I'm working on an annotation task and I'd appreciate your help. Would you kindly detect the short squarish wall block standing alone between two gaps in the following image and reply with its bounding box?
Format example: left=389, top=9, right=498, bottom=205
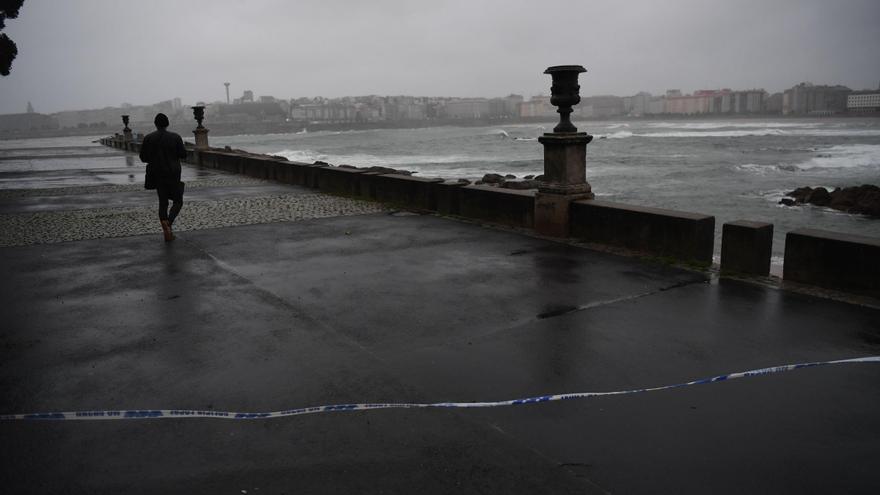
left=721, top=220, right=773, bottom=277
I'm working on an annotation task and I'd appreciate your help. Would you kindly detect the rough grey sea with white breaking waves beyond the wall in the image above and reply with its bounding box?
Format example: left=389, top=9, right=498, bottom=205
left=0, top=118, right=880, bottom=263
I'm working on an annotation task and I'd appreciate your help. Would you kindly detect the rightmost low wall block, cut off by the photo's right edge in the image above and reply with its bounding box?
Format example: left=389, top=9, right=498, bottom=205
left=782, top=229, right=880, bottom=297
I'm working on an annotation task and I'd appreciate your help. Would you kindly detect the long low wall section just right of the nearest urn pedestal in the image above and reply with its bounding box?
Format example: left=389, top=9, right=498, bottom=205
left=570, top=199, right=715, bottom=265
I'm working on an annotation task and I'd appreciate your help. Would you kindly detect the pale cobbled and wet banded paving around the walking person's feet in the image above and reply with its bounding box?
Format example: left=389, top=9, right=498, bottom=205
left=0, top=145, right=384, bottom=247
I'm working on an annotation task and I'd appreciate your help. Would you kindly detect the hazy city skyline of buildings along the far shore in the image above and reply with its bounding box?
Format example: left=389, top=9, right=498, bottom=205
left=0, top=83, right=880, bottom=137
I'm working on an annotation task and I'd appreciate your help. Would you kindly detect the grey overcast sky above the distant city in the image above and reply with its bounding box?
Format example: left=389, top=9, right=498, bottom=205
left=0, top=0, right=880, bottom=113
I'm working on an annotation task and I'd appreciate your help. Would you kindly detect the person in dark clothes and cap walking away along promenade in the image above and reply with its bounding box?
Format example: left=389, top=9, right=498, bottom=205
left=140, top=113, right=186, bottom=242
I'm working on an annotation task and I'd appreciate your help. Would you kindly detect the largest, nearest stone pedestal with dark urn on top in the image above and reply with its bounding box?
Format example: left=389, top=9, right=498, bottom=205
left=535, top=65, right=593, bottom=237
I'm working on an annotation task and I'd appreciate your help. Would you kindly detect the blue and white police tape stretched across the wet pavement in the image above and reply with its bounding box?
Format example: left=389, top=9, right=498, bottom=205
left=0, top=356, right=880, bottom=421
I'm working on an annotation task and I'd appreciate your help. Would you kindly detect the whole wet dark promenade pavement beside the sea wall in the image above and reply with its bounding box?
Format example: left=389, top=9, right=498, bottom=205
left=0, top=141, right=880, bottom=494
